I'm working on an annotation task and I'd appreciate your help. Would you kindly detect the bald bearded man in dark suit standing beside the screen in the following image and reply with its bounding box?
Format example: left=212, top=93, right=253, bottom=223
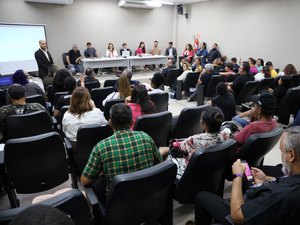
left=34, top=40, right=53, bottom=79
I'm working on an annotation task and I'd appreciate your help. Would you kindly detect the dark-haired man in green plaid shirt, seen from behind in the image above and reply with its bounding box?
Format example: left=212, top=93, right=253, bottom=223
left=81, top=103, right=162, bottom=192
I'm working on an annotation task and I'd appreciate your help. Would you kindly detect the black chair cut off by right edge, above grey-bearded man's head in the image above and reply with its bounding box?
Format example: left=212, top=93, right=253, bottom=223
left=275, top=86, right=300, bottom=125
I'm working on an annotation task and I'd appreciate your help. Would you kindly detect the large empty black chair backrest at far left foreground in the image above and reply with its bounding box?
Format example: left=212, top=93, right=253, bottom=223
left=4, top=132, right=69, bottom=193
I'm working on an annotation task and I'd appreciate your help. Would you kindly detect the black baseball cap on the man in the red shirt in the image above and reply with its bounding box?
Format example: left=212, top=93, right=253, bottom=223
left=251, top=92, right=277, bottom=114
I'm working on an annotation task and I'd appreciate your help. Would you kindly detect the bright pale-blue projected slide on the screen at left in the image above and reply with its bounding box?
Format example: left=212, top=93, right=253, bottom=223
left=0, top=23, right=46, bottom=75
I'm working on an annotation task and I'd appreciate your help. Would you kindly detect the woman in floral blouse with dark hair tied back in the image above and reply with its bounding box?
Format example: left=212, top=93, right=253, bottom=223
left=168, top=106, right=230, bottom=179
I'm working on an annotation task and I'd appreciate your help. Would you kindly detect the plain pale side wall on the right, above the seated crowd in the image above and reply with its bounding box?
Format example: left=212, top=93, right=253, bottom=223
left=178, top=0, right=300, bottom=70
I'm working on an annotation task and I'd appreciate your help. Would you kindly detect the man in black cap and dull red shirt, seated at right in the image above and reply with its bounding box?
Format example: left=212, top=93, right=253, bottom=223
left=234, top=92, right=277, bottom=145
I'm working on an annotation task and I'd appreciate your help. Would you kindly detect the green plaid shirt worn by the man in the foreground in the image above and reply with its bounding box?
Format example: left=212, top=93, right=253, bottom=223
left=82, top=129, right=162, bottom=183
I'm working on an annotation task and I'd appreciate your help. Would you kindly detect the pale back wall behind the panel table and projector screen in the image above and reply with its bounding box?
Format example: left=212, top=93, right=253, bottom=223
left=0, top=0, right=177, bottom=66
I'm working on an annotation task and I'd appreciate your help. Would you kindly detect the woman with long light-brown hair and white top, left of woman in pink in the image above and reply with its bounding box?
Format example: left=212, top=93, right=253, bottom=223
left=102, top=74, right=131, bottom=106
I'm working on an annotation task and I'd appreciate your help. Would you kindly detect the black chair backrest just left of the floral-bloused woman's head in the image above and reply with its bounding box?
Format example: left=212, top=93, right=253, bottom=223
left=171, top=105, right=208, bottom=138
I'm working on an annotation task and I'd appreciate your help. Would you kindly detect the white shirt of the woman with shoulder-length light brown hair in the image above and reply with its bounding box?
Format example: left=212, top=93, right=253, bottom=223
left=62, top=108, right=107, bottom=141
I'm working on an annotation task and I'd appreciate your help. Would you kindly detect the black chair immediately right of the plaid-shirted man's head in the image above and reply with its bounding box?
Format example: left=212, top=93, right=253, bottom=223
left=133, top=112, right=172, bottom=147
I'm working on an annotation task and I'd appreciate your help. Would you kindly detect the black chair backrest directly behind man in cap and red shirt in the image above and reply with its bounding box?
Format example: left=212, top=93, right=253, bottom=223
left=237, top=127, right=283, bottom=167
